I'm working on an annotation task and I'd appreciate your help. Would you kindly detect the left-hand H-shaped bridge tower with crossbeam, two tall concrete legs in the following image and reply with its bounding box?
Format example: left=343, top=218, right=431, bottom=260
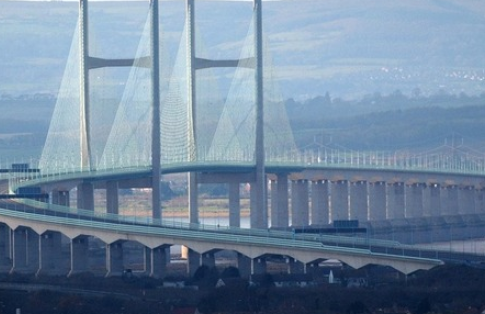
left=79, top=0, right=161, bottom=218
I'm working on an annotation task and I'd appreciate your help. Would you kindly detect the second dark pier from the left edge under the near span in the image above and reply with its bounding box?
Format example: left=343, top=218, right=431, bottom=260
left=11, top=227, right=39, bottom=273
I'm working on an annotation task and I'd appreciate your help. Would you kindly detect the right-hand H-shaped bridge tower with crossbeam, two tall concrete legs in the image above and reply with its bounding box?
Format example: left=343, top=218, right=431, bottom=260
left=186, top=0, right=268, bottom=228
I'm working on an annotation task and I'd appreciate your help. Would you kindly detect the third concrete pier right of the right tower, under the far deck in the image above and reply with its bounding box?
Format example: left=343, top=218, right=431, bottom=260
left=311, top=180, right=330, bottom=226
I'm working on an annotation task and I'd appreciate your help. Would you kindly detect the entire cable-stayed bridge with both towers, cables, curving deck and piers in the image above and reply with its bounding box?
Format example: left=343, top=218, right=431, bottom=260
left=0, top=0, right=485, bottom=276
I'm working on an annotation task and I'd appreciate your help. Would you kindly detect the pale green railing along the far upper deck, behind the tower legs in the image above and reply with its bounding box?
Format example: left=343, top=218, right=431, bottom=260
left=3, top=146, right=485, bottom=190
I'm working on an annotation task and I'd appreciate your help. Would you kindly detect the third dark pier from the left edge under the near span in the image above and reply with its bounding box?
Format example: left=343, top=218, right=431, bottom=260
left=37, top=231, right=64, bottom=275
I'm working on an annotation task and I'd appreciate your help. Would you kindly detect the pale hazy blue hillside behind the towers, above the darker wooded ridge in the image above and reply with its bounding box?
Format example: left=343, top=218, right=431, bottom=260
left=0, top=0, right=485, bottom=99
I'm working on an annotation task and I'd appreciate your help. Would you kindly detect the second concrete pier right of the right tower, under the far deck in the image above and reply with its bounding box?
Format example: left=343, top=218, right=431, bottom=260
left=291, top=180, right=309, bottom=227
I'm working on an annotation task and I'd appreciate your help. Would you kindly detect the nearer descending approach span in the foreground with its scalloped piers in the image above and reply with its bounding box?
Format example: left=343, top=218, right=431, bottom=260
left=0, top=201, right=442, bottom=277
